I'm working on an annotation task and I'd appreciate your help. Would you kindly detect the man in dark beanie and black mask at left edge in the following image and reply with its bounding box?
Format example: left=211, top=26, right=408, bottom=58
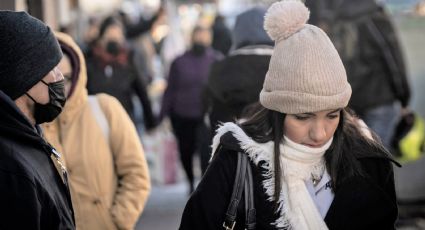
left=0, top=11, right=75, bottom=229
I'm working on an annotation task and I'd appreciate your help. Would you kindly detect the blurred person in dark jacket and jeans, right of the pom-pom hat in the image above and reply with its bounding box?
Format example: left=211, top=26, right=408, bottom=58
left=306, top=0, right=410, bottom=147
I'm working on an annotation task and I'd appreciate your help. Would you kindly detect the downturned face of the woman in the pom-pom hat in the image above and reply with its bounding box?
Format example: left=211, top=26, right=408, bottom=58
left=283, top=109, right=341, bottom=148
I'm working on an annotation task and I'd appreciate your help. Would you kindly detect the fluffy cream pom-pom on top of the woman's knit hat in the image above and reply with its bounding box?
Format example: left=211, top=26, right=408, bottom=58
left=264, top=0, right=310, bottom=41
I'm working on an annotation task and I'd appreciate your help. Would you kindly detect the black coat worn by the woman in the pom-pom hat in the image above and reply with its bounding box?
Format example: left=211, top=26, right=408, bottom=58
left=180, top=125, right=398, bottom=230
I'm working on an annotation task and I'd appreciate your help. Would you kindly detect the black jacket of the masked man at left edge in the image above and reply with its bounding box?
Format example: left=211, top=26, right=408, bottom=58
left=0, top=91, right=75, bottom=230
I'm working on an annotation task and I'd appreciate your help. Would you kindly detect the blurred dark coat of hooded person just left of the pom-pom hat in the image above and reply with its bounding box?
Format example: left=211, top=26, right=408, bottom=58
left=206, top=45, right=273, bottom=129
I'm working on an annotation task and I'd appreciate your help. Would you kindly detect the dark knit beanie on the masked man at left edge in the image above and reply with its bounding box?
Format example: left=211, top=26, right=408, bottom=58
left=0, top=11, right=62, bottom=100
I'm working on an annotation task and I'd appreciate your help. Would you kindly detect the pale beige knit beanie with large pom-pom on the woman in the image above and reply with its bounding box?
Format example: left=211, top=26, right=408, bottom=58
left=260, top=0, right=351, bottom=114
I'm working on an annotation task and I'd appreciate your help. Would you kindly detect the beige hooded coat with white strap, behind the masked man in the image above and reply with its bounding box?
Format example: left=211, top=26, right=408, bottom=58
left=43, top=34, right=150, bottom=230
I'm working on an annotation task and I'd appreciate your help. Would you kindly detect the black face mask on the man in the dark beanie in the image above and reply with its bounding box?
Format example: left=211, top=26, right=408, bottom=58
left=26, top=80, right=66, bottom=124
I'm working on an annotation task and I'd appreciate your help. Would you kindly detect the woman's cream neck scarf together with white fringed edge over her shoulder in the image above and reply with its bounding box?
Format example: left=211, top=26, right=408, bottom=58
left=212, top=122, right=333, bottom=230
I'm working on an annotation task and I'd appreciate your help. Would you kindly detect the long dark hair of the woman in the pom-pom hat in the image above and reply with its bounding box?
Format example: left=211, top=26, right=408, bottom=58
left=240, top=103, right=392, bottom=207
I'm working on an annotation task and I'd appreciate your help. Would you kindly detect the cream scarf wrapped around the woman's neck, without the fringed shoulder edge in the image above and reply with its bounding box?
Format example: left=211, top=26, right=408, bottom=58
left=280, top=136, right=333, bottom=230
